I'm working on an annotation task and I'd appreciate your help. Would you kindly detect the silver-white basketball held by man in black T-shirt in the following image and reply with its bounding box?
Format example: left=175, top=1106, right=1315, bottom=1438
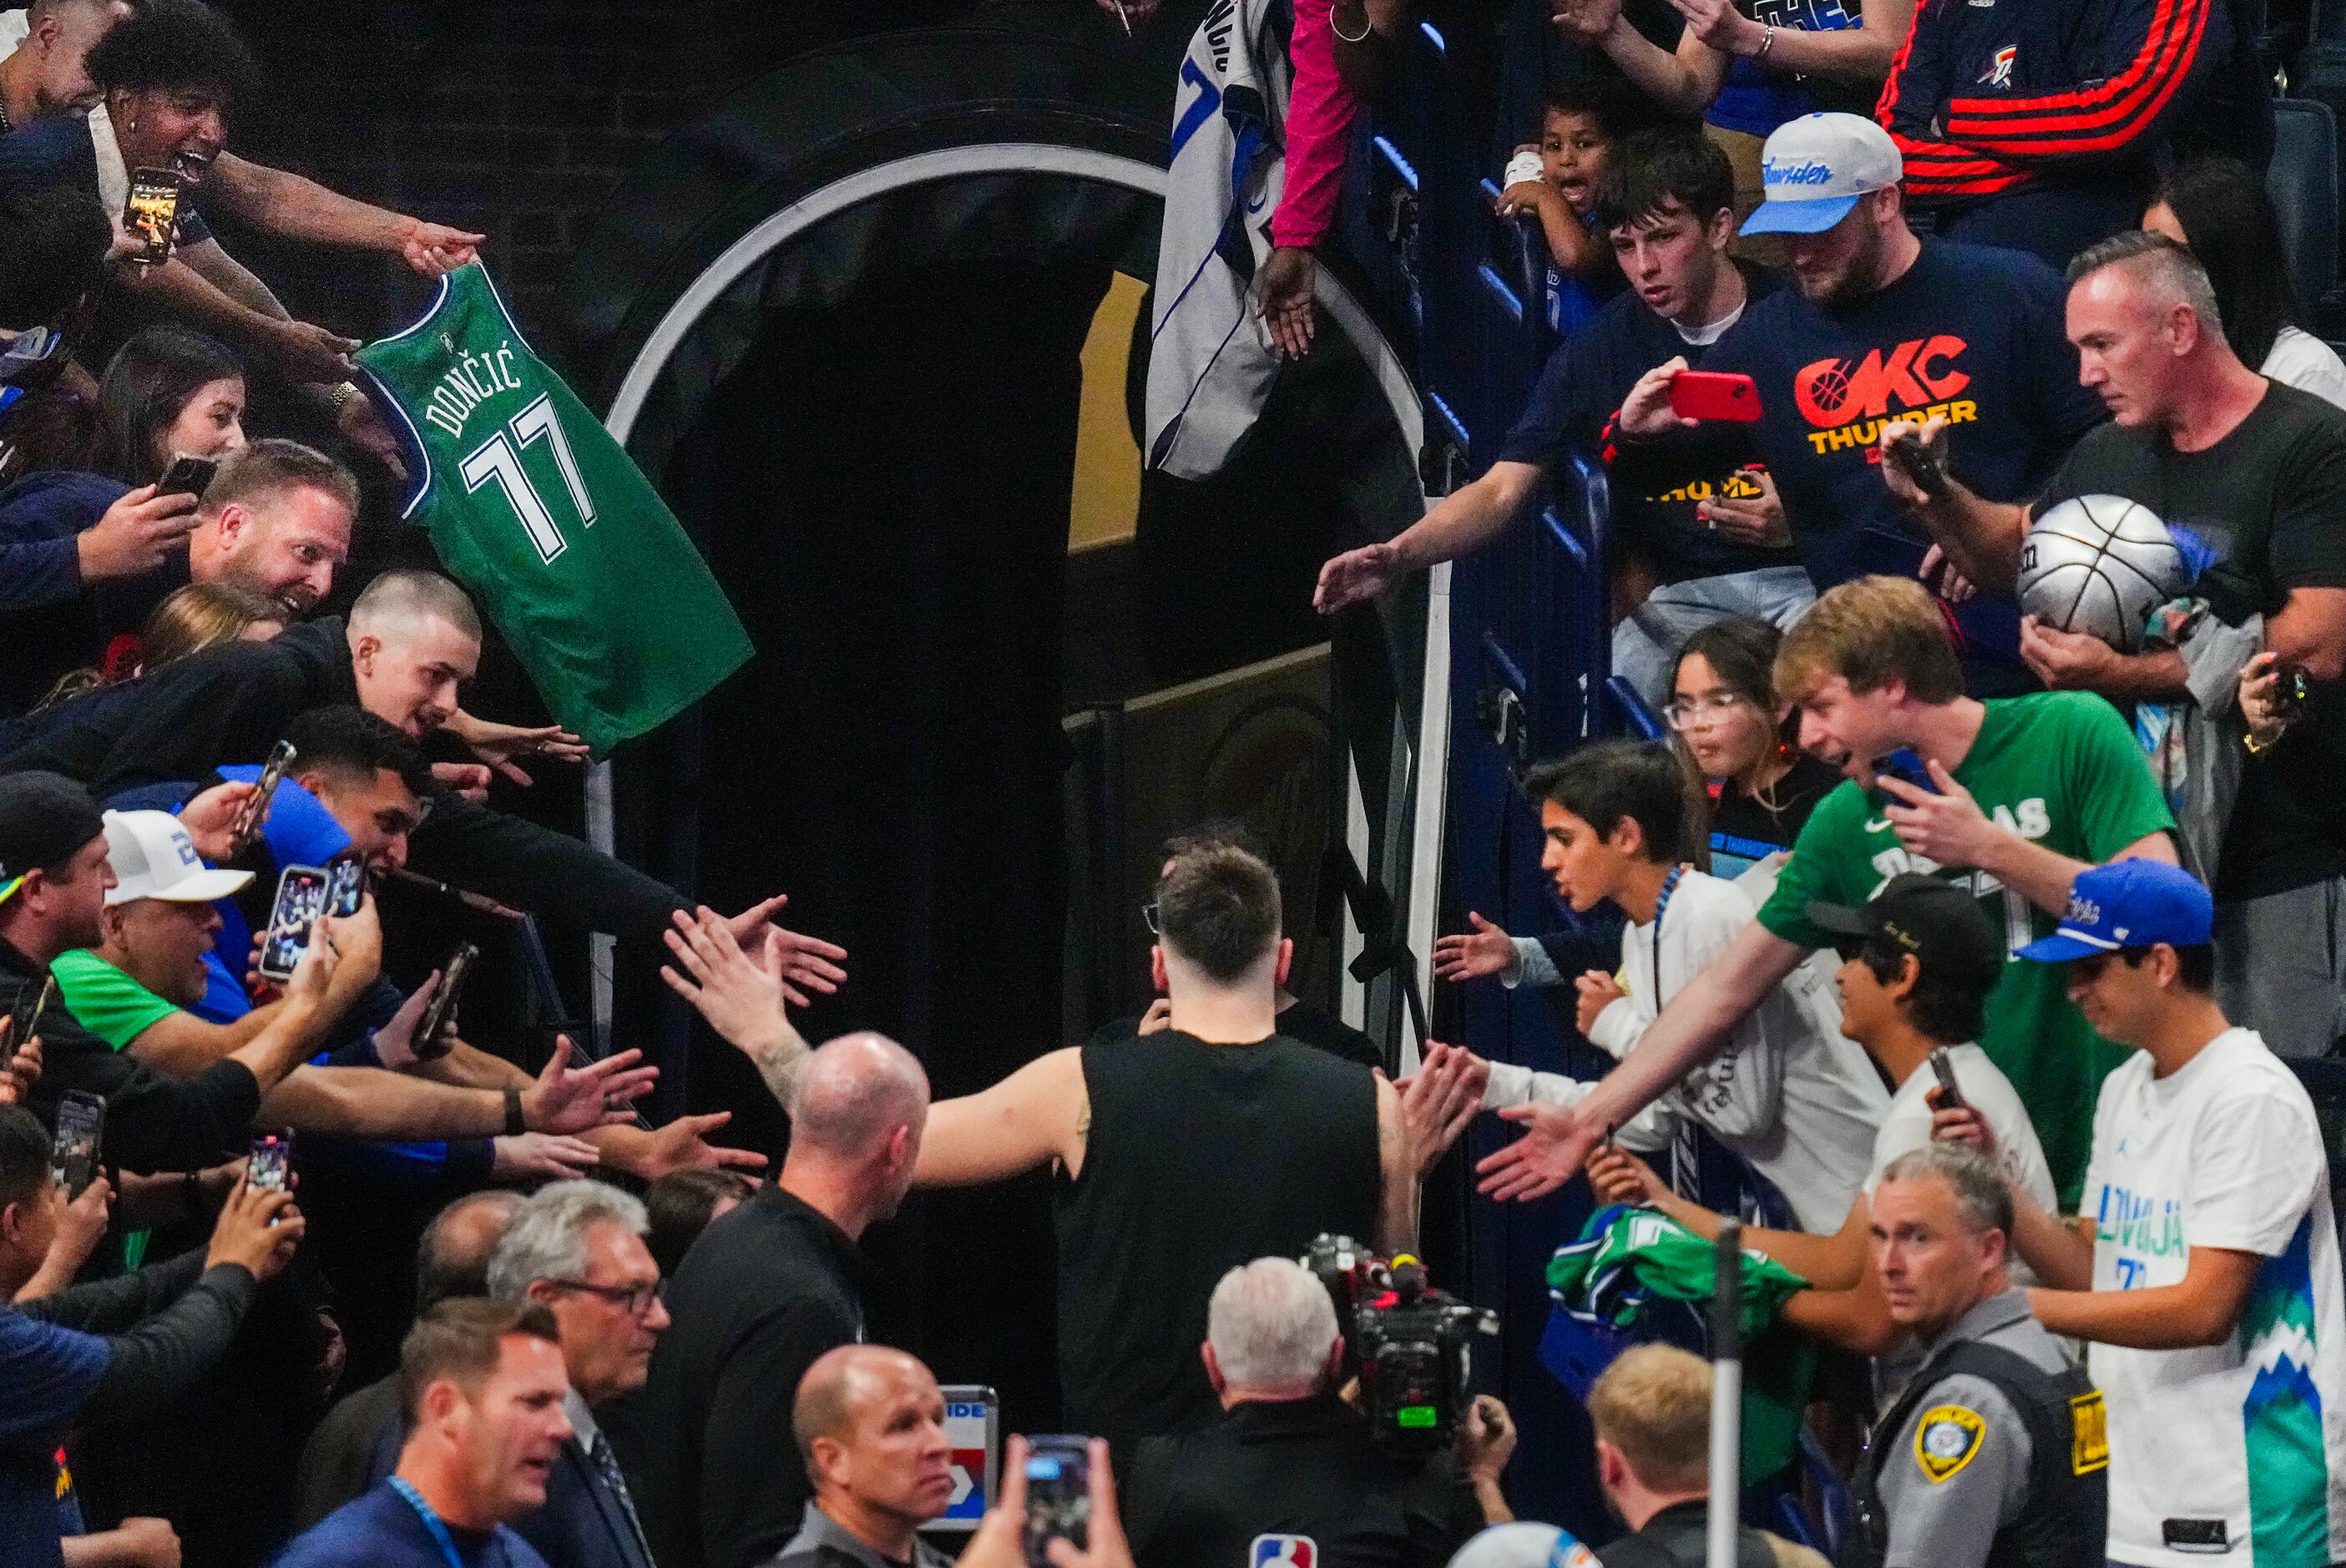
left=2020, top=495, right=2192, bottom=653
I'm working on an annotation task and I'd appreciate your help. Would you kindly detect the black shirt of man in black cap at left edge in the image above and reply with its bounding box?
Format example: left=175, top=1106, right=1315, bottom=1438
left=0, top=941, right=260, bottom=1171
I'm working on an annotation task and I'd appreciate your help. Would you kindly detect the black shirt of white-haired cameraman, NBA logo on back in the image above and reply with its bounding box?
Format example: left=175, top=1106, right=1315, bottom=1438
left=1124, top=1394, right=1483, bottom=1568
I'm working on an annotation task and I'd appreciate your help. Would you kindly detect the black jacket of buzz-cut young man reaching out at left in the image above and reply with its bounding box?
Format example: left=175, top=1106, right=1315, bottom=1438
left=0, top=615, right=685, bottom=943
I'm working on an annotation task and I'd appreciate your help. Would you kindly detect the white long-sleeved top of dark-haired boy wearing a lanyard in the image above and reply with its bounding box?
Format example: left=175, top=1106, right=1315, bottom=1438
left=1483, top=871, right=1888, bottom=1235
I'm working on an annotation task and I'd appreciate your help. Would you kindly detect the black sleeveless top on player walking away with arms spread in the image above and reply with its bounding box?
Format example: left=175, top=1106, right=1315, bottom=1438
left=1054, top=1028, right=1382, bottom=1446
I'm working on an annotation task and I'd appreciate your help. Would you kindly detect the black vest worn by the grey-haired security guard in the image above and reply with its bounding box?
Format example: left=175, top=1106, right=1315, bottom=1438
left=1853, top=1340, right=2109, bottom=1568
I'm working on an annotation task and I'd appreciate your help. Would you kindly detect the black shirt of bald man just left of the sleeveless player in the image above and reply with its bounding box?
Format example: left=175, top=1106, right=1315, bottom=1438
left=636, top=1186, right=871, bottom=1568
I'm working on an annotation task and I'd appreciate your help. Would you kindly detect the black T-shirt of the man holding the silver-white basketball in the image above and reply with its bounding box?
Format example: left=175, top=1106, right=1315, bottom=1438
left=2036, top=380, right=2346, bottom=903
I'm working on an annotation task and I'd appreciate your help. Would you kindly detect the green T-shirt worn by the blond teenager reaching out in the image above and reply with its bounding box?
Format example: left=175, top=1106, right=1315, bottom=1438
left=1760, top=692, right=2175, bottom=1204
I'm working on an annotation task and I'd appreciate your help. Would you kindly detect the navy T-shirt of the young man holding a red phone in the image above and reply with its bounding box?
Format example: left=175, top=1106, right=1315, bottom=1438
left=1499, top=267, right=1799, bottom=582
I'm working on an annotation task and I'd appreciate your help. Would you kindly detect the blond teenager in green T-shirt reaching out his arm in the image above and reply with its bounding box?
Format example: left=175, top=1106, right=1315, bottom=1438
left=1480, top=578, right=2175, bottom=1201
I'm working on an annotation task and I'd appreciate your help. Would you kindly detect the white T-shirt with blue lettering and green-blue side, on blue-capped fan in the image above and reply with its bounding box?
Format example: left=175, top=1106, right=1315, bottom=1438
left=2083, top=1028, right=2346, bottom=1568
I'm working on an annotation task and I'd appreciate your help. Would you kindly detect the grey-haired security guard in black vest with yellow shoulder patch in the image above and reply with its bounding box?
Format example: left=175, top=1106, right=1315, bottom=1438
left=1856, top=1143, right=2109, bottom=1568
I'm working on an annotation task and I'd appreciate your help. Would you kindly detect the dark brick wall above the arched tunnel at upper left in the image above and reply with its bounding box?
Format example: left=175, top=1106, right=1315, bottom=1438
left=218, top=0, right=1125, bottom=363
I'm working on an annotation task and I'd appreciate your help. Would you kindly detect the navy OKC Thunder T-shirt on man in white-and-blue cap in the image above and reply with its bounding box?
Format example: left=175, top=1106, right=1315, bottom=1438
left=1703, top=240, right=2102, bottom=591
